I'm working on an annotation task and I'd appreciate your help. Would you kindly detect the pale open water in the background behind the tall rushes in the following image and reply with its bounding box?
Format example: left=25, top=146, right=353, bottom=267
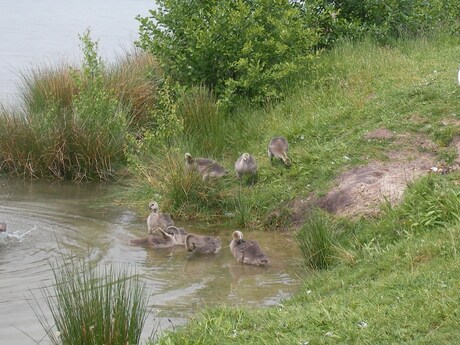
left=0, top=0, right=155, bottom=104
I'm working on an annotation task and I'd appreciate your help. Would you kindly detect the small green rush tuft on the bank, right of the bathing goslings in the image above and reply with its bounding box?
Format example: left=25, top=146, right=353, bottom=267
left=295, top=210, right=336, bottom=270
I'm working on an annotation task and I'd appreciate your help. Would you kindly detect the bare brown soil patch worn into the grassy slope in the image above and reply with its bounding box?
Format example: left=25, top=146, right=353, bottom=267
left=272, top=129, right=460, bottom=227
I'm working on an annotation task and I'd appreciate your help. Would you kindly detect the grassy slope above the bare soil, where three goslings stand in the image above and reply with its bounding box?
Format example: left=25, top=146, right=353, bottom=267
left=128, top=32, right=459, bottom=223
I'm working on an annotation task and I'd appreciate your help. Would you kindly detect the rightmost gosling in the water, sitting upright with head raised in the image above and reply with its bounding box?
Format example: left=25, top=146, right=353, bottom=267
left=230, top=231, right=269, bottom=266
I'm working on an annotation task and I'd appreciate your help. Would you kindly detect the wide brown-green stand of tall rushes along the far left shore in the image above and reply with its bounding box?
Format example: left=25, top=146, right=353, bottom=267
left=0, top=32, right=159, bottom=180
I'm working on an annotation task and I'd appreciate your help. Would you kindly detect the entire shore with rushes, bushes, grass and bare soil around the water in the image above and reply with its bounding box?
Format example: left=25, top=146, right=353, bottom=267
left=0, top=0, right=460, bottom=344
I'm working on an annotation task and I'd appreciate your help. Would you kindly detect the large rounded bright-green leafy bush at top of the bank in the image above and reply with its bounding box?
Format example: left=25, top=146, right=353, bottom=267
left=137, top=0, right=319, bottom=101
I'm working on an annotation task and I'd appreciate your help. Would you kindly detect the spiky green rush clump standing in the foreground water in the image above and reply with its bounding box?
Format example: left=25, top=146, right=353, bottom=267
left=33, top=259, right=148, bottom=345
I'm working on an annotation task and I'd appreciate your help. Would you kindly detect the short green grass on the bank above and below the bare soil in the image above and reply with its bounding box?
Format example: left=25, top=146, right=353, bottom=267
left=146, top=36, right=460, bottom=344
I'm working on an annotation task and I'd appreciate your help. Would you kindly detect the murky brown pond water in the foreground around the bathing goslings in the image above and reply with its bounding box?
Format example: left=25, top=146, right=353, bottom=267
left=0, top=178, right=299, bottom=345
